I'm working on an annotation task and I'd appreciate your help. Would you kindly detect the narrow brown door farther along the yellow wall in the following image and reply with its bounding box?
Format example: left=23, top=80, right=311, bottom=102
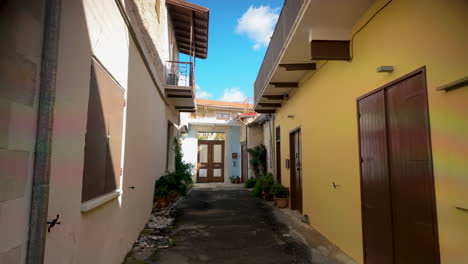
left=289, top=130, right=302, bottom=213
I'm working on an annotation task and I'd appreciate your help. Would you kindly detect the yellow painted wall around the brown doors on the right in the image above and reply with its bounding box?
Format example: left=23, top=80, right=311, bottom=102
left=275, top=0, right=468, bottom=264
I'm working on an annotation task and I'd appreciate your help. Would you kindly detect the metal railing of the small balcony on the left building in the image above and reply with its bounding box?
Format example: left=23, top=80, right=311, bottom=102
left=164, top=61, right=195, bottom=87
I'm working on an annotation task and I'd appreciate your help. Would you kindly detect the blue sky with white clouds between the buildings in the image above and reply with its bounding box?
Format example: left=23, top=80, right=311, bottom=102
left=183, top=0, right=284, bottom=101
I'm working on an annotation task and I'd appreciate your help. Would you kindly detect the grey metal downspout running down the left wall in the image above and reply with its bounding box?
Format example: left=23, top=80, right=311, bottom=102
left=26, top=0, right=62, bottom=264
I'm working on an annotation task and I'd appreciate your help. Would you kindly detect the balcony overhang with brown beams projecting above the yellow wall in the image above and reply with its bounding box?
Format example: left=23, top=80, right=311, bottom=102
left=255, top=0, right=375, bottom=113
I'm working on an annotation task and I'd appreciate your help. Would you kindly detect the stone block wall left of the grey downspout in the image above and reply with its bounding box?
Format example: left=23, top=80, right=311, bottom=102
left=0, top=0, right=44, bottom=263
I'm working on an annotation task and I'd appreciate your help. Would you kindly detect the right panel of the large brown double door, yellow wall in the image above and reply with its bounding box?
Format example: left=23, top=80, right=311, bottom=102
left=386, top=74, right=438, bottom=264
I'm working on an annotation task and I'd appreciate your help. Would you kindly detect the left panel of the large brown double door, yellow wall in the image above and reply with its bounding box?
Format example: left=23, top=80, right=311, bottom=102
left=359, top=91, right=393, bottom=264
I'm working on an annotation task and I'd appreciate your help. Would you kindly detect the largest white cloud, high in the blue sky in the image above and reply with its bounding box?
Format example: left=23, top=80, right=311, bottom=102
left=236, top=5, right=279, bottom=49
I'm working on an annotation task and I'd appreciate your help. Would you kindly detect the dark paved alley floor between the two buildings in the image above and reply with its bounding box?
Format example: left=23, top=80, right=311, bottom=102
left=155, top=185, right=312, bottom=264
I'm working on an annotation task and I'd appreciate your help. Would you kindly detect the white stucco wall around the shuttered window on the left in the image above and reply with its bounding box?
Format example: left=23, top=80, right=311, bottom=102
left=45, top=0, right=178, bottom=264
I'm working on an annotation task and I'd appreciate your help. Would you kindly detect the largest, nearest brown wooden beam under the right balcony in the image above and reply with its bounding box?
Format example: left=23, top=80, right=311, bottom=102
left=310, top=40, right=351, bottom=60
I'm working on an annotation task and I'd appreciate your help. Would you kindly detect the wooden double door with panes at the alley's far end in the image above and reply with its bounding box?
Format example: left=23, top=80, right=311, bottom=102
left=197, top=140, right=224, bottom=183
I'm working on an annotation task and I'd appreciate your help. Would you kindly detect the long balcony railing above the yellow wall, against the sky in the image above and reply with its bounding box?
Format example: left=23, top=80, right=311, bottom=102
left=254, top=0, right=305, bottom=102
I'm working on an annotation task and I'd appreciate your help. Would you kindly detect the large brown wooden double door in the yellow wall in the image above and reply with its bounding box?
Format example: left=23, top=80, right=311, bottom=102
left=358, top=68, right=440, bottom=264
